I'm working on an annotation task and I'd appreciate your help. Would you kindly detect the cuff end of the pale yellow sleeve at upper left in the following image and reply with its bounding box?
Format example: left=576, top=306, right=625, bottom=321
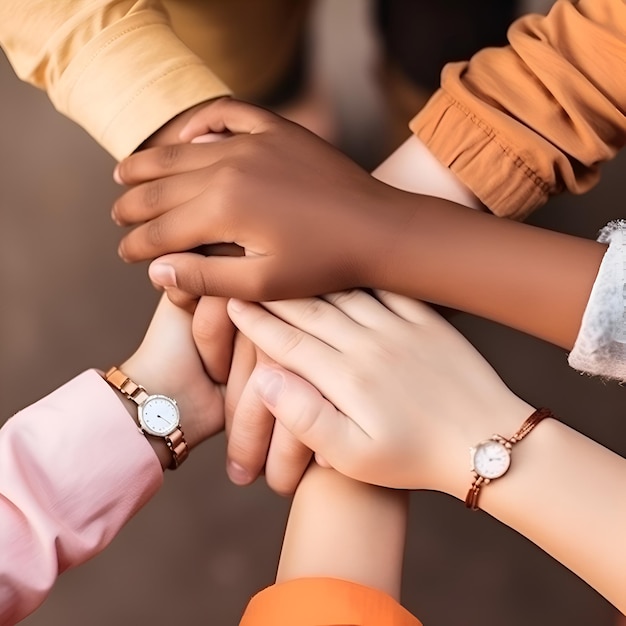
left=49, top=12, right=231, bottom=160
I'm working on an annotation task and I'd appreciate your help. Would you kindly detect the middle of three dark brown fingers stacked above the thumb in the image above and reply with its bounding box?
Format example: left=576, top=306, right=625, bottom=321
left=111, top=169, right=214, bottom=226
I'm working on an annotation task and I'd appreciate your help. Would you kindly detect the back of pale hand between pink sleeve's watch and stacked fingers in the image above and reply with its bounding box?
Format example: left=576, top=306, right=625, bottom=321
left=120, top=295, right=224, bottom=448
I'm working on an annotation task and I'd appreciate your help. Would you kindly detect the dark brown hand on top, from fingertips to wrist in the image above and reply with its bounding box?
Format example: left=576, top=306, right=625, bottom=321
left=113, top=99, right=411, bottom=300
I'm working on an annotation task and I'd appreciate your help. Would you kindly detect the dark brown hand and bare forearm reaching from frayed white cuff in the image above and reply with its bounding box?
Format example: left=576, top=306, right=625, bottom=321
left=113, top=99, right=606, bottom=348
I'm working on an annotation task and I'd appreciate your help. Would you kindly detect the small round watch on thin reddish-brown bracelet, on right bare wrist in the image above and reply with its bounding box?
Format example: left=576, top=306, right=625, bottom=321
left=465, top=408, right=554, bottom=511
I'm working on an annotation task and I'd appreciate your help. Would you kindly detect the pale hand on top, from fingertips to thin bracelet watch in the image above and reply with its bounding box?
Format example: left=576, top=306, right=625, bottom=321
left=228, top=291, right=533, bottom=498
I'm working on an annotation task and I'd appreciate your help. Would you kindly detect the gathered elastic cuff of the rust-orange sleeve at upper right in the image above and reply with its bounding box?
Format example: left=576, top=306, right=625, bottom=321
left=410, top=89, right=551, bottom=220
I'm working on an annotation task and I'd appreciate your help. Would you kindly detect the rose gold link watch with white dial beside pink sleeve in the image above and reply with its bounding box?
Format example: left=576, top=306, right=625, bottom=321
left=104, top=367, right=189, bottom=469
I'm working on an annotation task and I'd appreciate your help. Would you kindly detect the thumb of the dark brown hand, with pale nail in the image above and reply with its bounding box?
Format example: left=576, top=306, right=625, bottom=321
left=147, top=252, right=271, bottom=300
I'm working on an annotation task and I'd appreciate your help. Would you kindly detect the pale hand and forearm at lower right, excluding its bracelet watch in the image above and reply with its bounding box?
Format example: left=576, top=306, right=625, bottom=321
left=229, top=291, right=626, bottom=611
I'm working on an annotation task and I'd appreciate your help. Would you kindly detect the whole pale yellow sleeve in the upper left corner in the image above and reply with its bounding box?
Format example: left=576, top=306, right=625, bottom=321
left=0, top=0, right=230, bottom=160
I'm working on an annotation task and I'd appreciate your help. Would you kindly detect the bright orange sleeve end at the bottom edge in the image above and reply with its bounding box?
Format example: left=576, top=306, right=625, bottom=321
left=239, top=578, right=421, bottom=626
